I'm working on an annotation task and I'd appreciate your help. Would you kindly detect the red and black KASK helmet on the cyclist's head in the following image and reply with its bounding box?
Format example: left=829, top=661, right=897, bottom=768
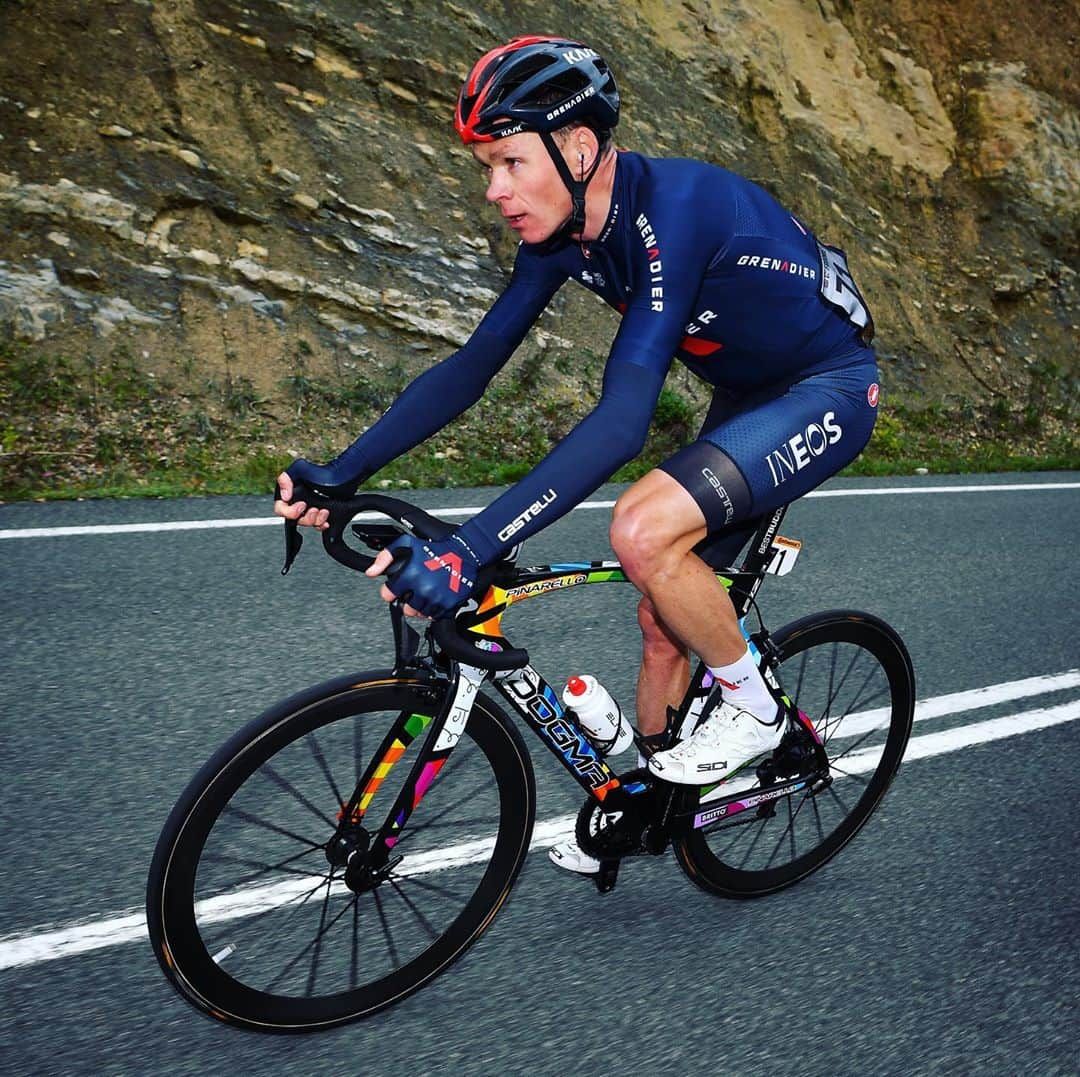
left=454, top=37, right=619, bottom=145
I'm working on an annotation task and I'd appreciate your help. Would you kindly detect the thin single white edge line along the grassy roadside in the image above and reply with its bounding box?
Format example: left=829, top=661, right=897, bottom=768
left=0, top=483, right=1080, bottom=539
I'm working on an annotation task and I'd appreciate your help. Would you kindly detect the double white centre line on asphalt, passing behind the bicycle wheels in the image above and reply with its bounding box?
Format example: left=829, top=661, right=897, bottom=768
left=0, top=670, right=1080, bottom=969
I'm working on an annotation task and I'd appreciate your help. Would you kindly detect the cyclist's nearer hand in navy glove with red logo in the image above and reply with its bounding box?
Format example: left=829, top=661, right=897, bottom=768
left=367, top=535, right=480, bottom=617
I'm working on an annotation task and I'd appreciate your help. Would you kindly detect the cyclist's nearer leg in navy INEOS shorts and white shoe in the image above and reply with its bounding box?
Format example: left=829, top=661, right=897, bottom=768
left=611, top=362, right=877, bottom=782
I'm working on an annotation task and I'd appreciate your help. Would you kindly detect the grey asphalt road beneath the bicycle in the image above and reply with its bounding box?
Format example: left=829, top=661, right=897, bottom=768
left=0, top=473, right=1080, bottom=1075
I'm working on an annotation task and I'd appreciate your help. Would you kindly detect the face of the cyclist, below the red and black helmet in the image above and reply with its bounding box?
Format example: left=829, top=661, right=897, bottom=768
left=472, top=132, right=570, bottom=243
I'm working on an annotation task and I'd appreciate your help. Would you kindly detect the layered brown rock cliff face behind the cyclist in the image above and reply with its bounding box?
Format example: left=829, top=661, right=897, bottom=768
left=0, top=0, right=1080, bottom=479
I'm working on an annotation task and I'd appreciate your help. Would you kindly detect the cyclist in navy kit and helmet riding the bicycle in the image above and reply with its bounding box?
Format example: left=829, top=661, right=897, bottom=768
left=275, top=37, right=878, bottom=873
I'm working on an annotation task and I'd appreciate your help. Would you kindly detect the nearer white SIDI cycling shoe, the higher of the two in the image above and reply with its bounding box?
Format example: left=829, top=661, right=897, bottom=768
left=649, top=702, right=786, bottom=785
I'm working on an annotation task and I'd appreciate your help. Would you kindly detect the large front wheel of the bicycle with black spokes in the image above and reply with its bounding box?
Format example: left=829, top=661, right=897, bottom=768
left=147, top=672, right=536, bottom=1033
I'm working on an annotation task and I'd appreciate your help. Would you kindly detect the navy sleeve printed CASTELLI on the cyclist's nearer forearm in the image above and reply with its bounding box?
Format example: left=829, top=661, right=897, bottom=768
left=458, top=363, right=663, bottom=564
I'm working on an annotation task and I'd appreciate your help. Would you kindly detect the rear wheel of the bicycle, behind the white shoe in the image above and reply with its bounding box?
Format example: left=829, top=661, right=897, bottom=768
left=675, top=610, right=915, bottom=898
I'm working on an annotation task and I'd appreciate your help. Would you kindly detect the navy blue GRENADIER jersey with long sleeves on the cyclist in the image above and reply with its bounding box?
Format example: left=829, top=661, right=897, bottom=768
left=356, top=152, right=873, bottom=563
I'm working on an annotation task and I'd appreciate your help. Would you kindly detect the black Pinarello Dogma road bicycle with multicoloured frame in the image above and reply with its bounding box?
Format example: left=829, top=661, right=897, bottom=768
left=147, top=489, right=915, bottom=1032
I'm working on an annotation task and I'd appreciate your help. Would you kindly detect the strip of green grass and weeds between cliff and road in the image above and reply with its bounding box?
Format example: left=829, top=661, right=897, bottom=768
left=0, top=345, right=1080, bottom=500
